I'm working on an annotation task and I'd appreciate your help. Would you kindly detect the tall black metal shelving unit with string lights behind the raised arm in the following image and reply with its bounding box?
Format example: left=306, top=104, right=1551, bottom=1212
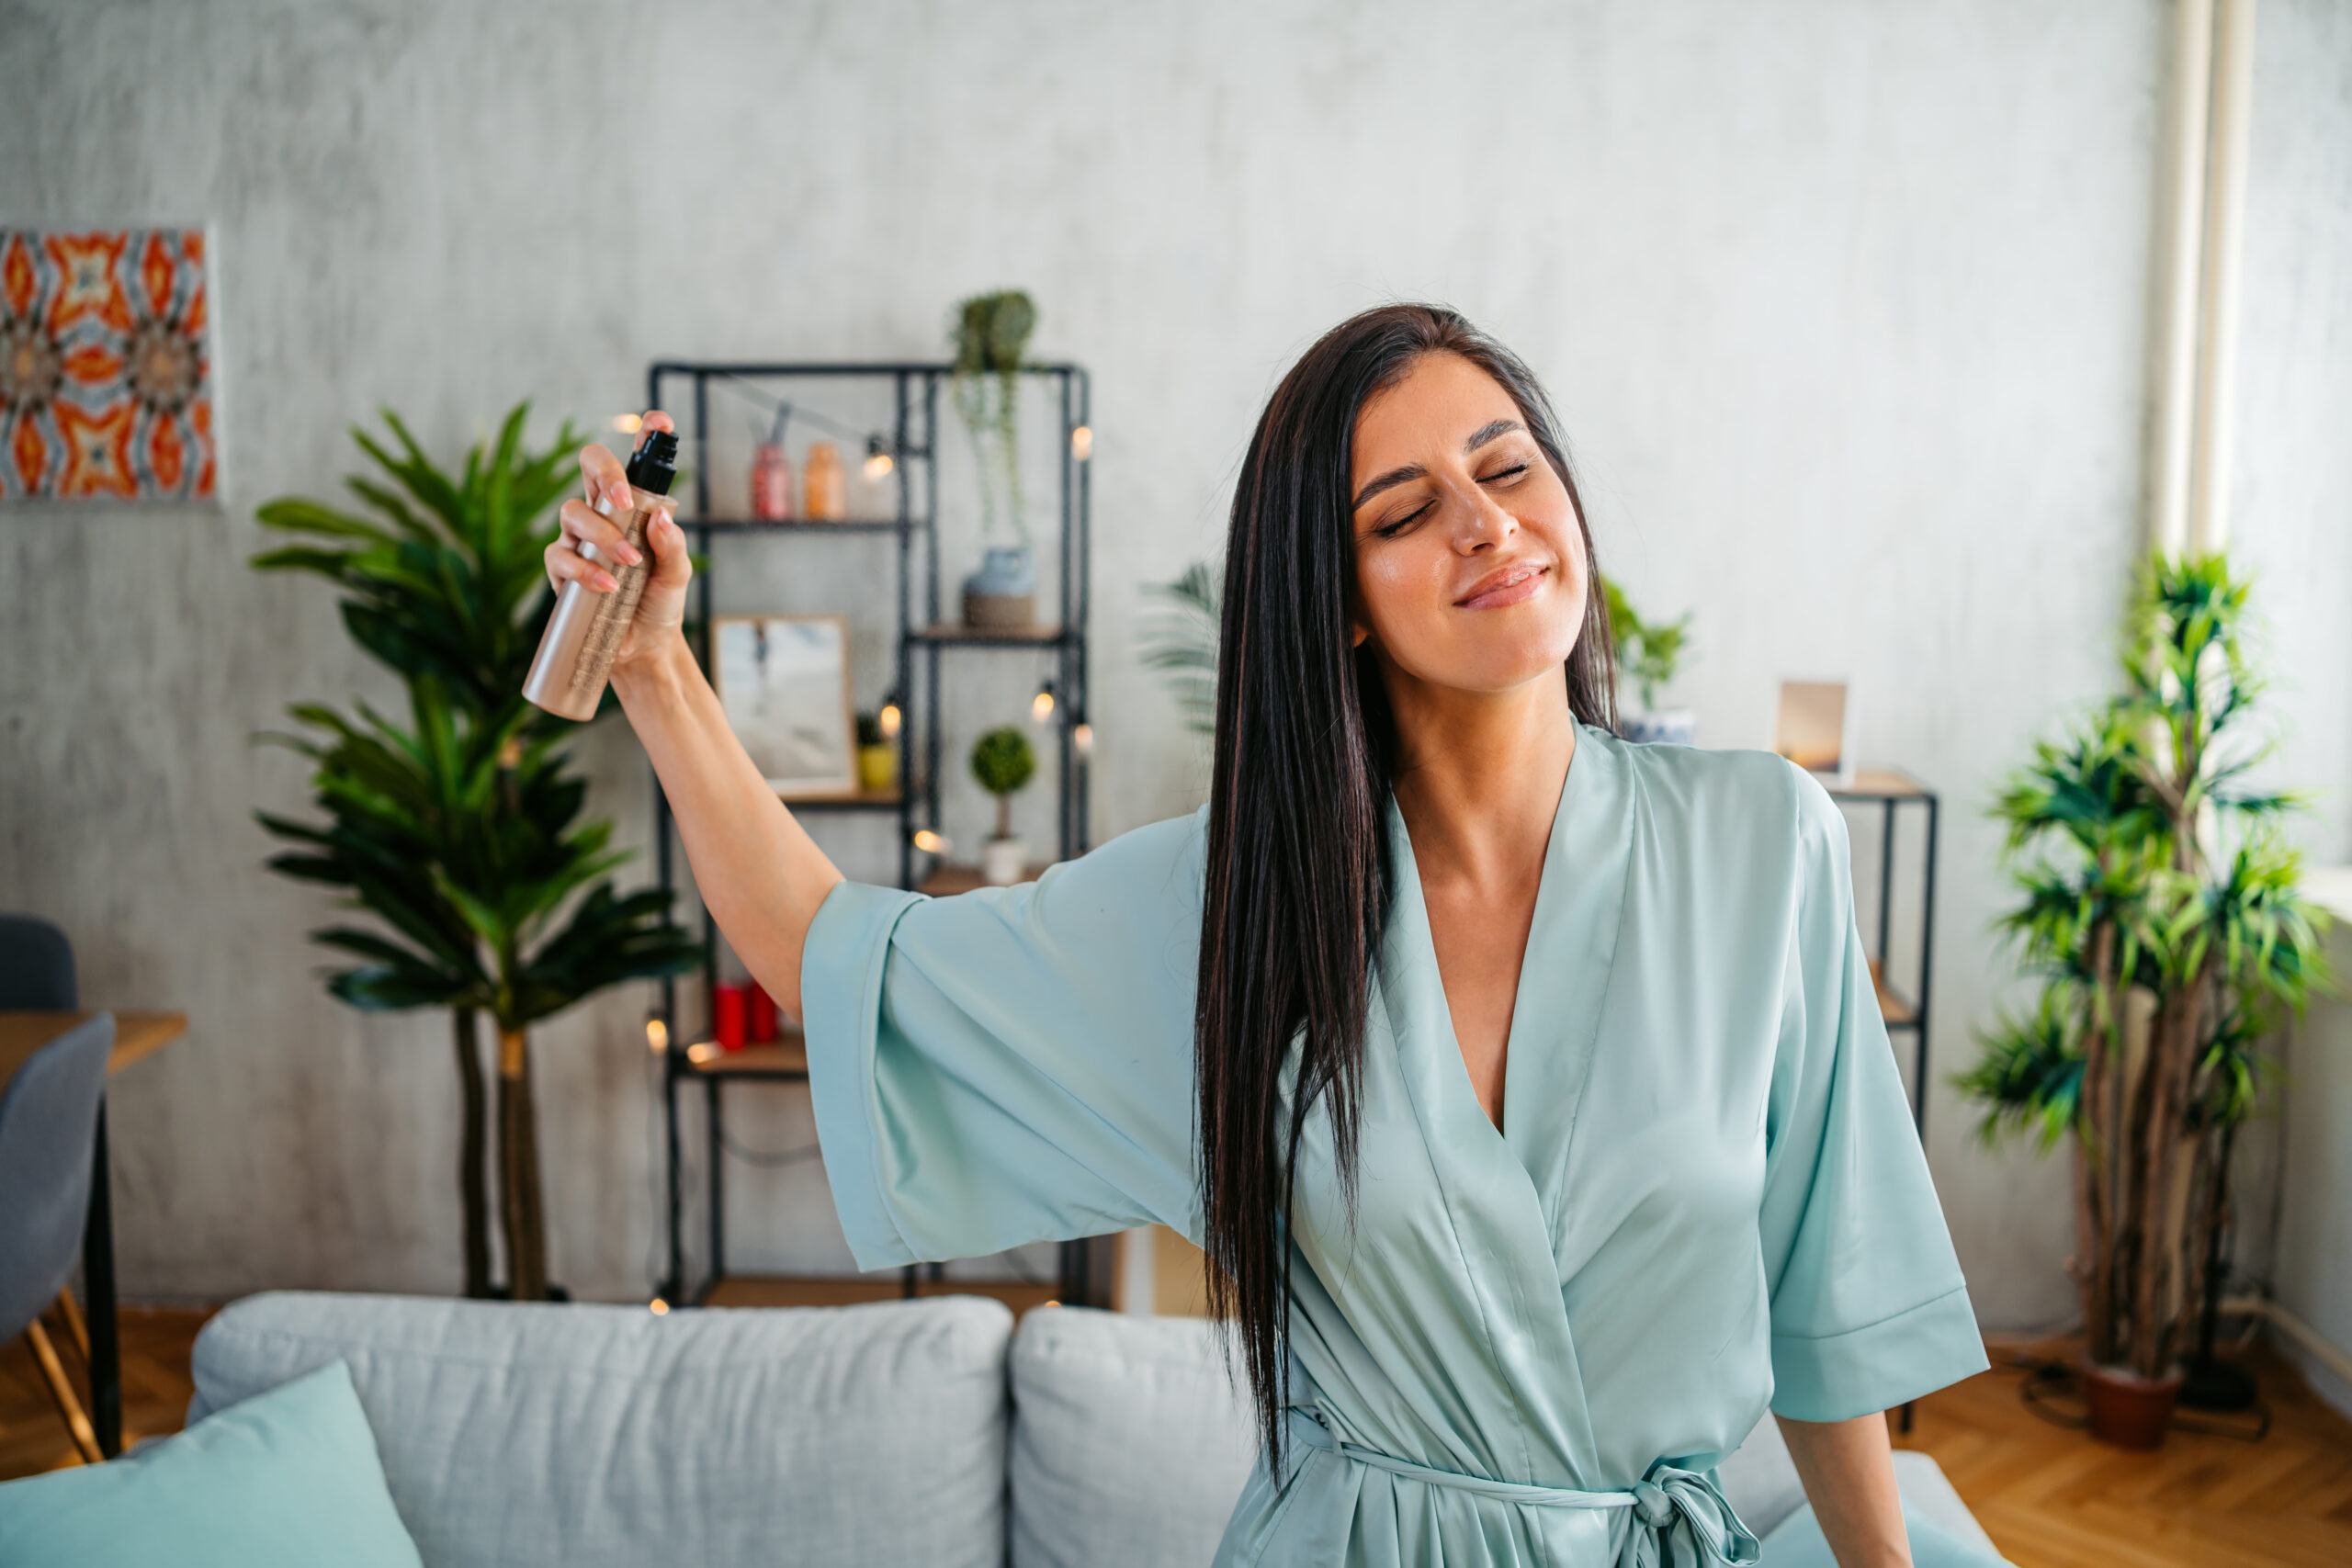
left=647, top=360, right=1110, bottom=1304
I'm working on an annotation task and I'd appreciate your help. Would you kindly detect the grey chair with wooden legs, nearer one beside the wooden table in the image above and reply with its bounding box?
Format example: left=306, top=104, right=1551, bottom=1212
left=0, top=1013, right=115, bottom=1464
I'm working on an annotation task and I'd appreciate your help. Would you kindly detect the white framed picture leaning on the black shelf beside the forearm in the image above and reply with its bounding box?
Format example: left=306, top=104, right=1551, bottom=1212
left=710, top=616, right=858, bottom=799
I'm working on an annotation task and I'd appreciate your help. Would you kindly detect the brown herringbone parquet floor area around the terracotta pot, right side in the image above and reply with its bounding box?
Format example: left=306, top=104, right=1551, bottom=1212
left=1895, top=1342, right=2352, bottom=1568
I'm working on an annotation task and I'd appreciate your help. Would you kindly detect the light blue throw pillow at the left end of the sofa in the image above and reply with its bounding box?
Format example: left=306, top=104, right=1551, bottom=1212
left=0, top=1361, right=424, bottom=1568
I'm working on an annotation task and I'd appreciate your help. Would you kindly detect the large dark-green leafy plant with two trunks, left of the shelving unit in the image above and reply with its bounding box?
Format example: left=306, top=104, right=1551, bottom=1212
left=254, top=404, right=701, bottom=1300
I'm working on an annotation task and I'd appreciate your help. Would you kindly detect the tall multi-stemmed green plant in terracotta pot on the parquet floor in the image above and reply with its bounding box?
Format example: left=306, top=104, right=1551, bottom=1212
left=1952, top=555, right=2326, bottom=1448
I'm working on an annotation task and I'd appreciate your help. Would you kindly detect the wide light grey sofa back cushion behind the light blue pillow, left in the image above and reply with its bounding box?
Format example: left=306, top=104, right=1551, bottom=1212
left=188, top=1293, right=1012, bottom=1568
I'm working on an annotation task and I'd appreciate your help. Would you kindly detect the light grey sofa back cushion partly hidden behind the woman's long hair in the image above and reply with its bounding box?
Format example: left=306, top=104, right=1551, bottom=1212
left=1012, top=1307, right=1259, bottom=1568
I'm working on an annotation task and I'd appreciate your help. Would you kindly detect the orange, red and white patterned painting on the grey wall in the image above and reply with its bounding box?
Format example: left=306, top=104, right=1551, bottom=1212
left=0, top=228, right=214, bottom=501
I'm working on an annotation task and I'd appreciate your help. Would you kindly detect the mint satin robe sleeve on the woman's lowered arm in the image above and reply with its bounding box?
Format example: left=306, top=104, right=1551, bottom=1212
left=1759, top=764, right=1990, bottom=1422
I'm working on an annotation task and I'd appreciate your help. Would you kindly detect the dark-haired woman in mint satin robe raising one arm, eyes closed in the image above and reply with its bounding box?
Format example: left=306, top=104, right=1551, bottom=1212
left=548, top=306, right=1985, bottom=1568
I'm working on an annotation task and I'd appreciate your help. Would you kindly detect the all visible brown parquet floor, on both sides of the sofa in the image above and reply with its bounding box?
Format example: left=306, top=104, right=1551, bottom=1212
left=14, top=1309, right=2352, bottom=1568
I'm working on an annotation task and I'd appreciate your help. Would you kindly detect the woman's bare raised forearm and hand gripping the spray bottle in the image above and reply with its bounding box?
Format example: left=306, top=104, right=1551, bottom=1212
left=546, top=409, right=842, bottom=1018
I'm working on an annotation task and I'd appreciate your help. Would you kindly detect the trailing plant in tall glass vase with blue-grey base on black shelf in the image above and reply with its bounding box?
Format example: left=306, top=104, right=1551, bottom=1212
left=948, top=289, right=1037, bottom=632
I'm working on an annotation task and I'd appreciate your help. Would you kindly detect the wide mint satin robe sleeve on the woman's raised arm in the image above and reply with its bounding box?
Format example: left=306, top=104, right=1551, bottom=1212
left=799, top=813, right=1202, bottom=1269
